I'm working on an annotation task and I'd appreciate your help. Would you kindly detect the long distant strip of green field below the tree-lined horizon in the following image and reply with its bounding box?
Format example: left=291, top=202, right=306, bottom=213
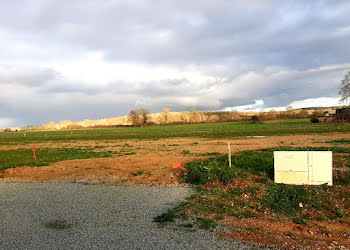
left=0, top=120, right=350, bottom=145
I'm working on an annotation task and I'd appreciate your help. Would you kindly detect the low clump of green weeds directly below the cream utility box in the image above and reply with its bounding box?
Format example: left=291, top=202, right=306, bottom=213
left=261, top=184, right=310, bottom=215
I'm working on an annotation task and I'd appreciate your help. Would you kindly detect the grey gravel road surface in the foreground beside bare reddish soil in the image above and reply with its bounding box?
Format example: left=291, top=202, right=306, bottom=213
left=0, top=182, right=258, bottom=249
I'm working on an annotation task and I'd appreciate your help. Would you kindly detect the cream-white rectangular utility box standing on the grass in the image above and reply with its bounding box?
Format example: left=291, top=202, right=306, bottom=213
left=274, top=151, right=333, bottom=185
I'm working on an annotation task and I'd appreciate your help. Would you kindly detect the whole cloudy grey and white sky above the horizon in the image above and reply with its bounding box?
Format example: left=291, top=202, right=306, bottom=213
left=0, top=0, right=350, bottom=128
